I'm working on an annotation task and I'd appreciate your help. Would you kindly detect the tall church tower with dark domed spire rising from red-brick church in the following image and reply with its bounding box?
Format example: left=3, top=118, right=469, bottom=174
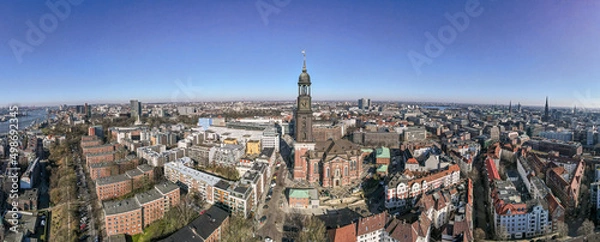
left=294, top=51, right=315, bottom=180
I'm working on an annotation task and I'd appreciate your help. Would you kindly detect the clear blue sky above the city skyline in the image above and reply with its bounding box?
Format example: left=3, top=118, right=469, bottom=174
left=0, top=0, right=600, bottom=106
